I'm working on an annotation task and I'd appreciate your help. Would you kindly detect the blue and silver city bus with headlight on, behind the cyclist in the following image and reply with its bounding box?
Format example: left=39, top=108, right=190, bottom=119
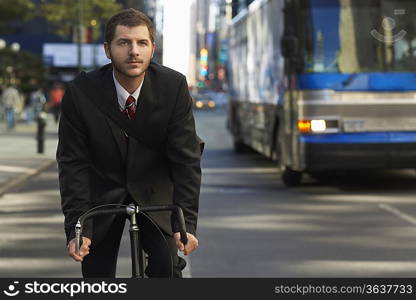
left=227, top=0, right=416, bottom=186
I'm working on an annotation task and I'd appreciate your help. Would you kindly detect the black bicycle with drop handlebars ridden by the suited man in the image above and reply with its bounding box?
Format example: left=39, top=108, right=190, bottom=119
left=75, top=203, right=188, bottom=278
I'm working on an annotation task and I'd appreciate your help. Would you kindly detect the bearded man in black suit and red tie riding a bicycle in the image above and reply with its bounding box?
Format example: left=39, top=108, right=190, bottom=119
left=57, top=9, right=201, bottom=277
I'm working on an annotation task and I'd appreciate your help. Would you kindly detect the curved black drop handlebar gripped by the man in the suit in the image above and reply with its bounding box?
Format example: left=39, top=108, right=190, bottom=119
left=75, top=204, right=188, bottom=253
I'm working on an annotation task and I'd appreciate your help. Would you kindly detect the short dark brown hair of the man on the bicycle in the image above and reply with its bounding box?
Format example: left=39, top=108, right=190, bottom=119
left=105, top=8, right=155, bottom=44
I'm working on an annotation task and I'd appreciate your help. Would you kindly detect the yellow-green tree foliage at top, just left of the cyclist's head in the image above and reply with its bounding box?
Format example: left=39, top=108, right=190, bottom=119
left=40, top=0, right=122, bottom=41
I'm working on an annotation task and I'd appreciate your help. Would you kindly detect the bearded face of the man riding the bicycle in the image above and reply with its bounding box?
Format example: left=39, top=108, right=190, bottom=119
left=104, top=25, right=155, bottom=78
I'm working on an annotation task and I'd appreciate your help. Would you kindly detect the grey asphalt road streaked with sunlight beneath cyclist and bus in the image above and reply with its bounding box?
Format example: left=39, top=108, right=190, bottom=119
left=0, top=107, right=416, bottom=277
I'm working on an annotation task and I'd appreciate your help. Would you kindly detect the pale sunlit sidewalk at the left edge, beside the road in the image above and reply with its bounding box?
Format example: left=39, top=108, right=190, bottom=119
left=0, top=115, right=58, bottom=197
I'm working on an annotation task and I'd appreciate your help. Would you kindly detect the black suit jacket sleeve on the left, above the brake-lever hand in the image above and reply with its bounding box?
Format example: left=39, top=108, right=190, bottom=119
left=56, top=84, right=92, bottom=243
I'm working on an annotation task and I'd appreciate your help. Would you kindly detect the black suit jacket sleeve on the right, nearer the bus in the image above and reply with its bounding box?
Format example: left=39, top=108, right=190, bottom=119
left=166, top=77, right=202, bottom=235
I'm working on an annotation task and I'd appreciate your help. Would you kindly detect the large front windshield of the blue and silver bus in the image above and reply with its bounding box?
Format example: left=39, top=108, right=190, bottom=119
left=297, top=0, right=416, bottom=73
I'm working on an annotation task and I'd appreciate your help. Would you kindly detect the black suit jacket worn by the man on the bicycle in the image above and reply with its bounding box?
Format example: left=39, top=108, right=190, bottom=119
left=57, top=63, right=202, bottom=244
